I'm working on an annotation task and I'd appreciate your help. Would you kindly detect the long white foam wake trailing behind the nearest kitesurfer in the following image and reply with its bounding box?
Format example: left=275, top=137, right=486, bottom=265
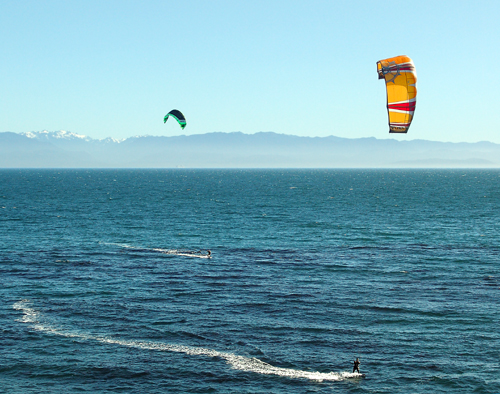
left=12, top=300, right=361, bottom=381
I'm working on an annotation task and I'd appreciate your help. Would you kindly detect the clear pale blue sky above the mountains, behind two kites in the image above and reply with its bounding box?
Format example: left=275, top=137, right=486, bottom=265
left=0, top=0, right=500, bottom=143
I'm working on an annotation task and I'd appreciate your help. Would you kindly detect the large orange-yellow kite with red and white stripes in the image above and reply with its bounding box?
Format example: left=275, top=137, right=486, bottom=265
left=377, top=56, right=417, bottom=133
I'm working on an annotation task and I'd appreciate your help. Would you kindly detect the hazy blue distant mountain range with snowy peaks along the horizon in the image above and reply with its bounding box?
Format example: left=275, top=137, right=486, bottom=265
left=0, top=131, right=500, bottom=168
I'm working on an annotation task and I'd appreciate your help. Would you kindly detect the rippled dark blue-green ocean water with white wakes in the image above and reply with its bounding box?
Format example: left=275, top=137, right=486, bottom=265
left=0, top=169, right=500, bottom=394
